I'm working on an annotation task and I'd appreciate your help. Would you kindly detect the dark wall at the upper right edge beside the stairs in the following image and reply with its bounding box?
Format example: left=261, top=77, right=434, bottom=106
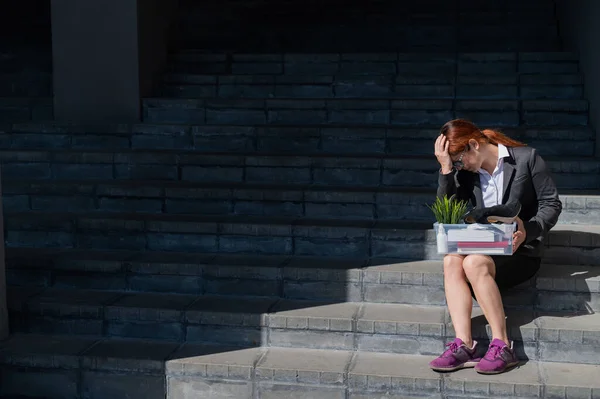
left=557, top=0, right=600, bottom=157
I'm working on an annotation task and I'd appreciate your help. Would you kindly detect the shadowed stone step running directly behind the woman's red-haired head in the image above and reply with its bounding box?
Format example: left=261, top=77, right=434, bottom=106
left=0, top=122, right=596, bottom=157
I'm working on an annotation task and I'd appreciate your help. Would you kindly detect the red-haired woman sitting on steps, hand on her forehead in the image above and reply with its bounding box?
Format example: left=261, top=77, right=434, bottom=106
left=430, top=119, right=562, bottom=374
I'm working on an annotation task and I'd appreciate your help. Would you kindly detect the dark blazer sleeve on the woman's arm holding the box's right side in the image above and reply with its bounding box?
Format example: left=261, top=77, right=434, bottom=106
left=523, top=149, right=562, bottom=244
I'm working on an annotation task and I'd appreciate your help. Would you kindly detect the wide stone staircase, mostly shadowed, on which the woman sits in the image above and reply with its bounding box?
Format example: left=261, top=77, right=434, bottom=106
left=0, top=0, right=600, bottom=399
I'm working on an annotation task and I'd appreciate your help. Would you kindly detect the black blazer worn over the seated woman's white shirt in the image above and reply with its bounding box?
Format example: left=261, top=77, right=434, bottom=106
left=437, top=147, right=562, bottom=257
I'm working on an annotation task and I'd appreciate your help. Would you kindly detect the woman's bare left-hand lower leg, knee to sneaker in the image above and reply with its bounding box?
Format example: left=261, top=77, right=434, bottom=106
left=444, top=255, right=473, bottom=348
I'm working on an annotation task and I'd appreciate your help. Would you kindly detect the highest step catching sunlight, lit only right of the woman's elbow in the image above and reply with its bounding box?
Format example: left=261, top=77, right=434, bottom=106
left=2, top=180, right=600, bottom=224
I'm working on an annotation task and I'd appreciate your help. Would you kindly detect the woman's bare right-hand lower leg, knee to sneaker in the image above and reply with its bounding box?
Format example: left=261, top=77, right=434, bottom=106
left=463, top=255, right=509, bottom=343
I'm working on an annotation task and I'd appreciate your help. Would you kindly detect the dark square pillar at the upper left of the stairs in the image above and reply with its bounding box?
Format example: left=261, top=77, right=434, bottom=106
left=52, top=0, right=176, bottom=122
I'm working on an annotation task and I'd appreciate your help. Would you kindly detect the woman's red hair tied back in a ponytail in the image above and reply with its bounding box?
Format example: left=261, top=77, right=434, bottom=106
left=440, top=119, right=527, bottom=155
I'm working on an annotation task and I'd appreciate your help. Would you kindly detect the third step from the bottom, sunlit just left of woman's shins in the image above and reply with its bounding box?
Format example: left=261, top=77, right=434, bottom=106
left=6, top=241, right=600, bottom=311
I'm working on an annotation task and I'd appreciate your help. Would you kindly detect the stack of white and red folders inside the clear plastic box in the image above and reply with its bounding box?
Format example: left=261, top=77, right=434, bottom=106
left=448, top=225, right=512, bottom=255
